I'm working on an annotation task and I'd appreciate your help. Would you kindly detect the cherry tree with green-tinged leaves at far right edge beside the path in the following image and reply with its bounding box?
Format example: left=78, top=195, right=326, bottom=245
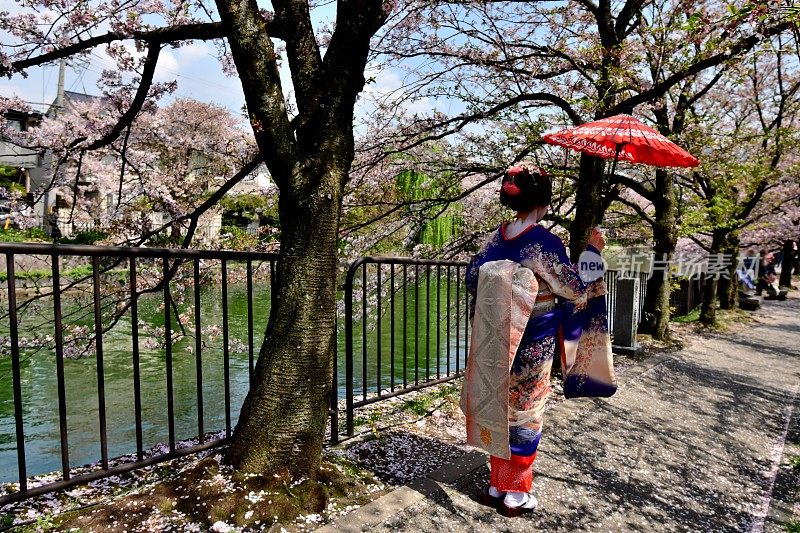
left=681, top=36, right=800, bottom=324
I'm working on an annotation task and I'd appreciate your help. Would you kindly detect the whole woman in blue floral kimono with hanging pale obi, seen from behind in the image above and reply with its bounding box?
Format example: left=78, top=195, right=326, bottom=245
left=461, top=165, right=616, bottom=516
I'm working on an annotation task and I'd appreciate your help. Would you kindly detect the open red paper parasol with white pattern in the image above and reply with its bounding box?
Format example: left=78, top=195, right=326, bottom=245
left=544, top=115, right=700, bottom=167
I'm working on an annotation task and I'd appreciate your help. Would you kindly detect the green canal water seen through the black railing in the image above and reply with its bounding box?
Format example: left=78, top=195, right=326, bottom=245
left=0, top=272, right=466, bottom=482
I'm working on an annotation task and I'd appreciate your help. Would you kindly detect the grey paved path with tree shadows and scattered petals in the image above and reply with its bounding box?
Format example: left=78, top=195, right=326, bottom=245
left=317, top=293, right=800, bottom=533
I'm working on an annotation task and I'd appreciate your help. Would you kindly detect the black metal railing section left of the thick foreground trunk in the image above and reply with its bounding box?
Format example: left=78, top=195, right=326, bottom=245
left=0, top=244, right=278, bottom=505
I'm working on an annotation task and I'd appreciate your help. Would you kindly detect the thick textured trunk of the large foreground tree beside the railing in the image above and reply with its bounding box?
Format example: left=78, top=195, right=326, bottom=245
left=216, top=0, right=390, bottom=479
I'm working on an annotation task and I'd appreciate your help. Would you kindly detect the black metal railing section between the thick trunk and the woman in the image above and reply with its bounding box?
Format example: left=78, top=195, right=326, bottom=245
left=332, top=257, right=470, bottom=440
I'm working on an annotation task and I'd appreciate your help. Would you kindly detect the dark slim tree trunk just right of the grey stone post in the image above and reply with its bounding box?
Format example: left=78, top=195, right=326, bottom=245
left=639, top=169, right=678, bottom=340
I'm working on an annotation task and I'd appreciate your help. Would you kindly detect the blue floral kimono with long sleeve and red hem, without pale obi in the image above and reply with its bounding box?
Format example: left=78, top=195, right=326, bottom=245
left=462, top=225, right=616, bottom=492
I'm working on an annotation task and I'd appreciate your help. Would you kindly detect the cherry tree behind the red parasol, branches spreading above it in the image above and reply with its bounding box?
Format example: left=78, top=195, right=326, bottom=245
left=368, top=0, right=793, bottom=256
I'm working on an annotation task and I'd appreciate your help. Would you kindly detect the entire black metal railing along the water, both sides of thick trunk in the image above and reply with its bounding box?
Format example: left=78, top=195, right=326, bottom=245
left=0, top=244, right=646, bottom=505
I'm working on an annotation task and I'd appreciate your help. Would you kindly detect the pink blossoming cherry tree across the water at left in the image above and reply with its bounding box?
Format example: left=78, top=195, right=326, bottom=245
left=5, top=99, right=254, bottom=245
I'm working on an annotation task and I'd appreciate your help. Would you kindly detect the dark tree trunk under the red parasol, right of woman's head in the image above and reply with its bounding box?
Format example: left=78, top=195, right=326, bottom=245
left=569, top=154, right=606, bottom=262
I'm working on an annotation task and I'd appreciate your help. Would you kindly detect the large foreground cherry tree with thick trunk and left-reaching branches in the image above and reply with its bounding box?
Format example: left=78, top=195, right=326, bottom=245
left=0, top=0, right=393, bottom=479
